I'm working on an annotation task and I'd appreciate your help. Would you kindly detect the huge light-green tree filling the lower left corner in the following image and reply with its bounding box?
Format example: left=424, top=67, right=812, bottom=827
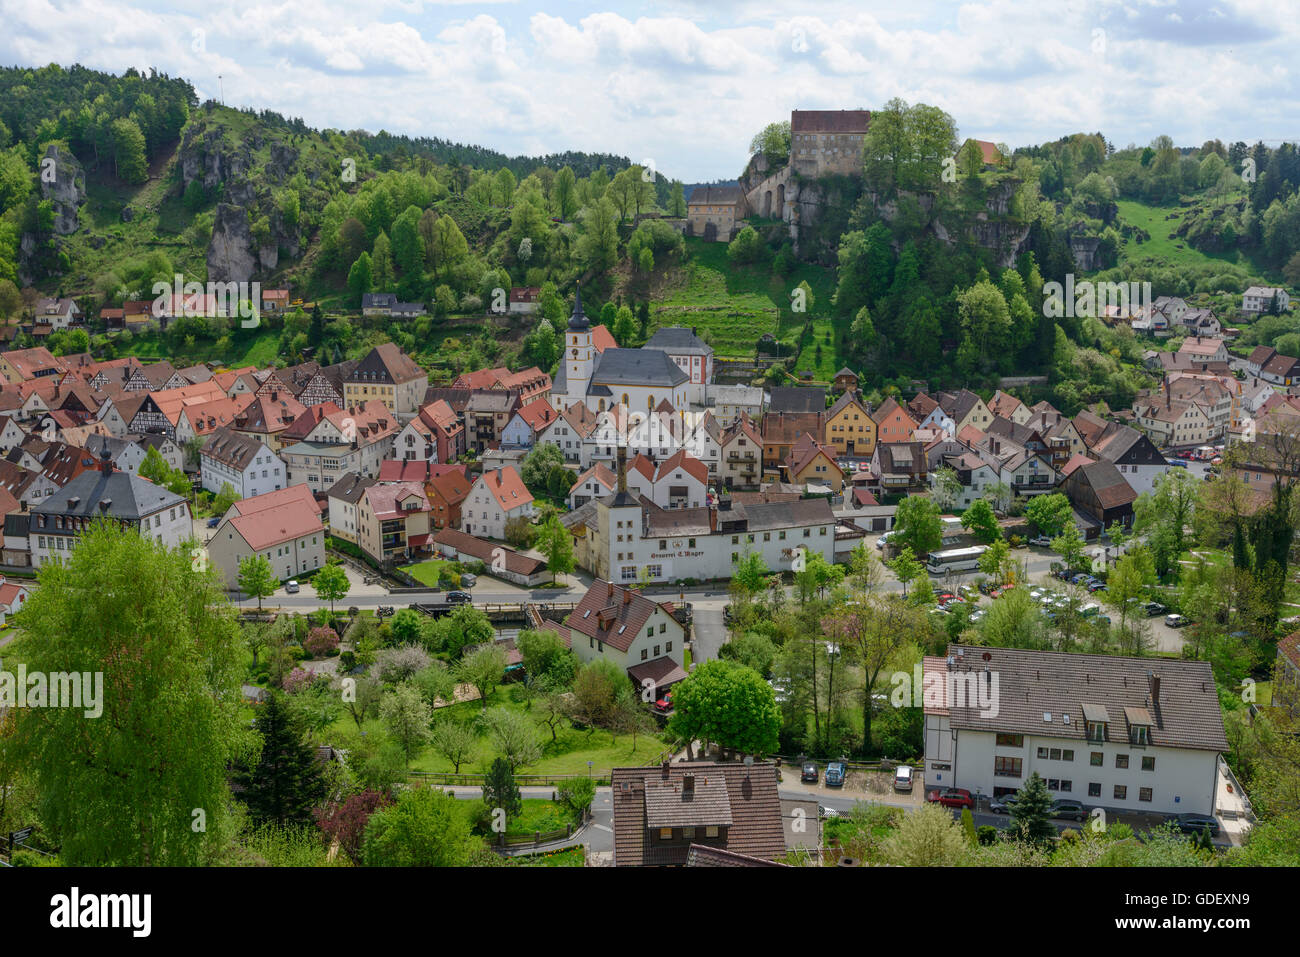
left=16, top=523, right=247, bottom=866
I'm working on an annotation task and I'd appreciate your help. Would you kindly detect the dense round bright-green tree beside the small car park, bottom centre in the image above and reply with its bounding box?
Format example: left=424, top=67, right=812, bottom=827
left=668, top=659, right=781, bottom=755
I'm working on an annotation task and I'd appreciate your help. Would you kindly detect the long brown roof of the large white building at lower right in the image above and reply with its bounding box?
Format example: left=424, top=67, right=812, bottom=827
left=924, top=645, right=1227, bottom=752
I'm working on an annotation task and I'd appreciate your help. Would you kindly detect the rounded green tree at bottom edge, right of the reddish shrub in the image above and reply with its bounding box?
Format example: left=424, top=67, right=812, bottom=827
left=361, top=788, right=482, bottom=867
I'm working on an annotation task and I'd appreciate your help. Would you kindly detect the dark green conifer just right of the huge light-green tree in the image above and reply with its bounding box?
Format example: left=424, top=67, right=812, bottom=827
left=235, top=692, right=325, bottom=826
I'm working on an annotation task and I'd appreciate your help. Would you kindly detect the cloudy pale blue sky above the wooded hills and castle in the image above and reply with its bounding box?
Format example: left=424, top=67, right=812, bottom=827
left=0, top=0, right=1300, bottom=183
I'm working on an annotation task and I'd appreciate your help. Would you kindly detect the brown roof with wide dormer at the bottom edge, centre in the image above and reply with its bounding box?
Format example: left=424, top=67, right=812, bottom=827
left=611, top=761, right=785, bottom=867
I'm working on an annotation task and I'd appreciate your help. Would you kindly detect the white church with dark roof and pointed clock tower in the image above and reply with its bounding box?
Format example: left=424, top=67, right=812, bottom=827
left=551, top=289, right=690, bottom=413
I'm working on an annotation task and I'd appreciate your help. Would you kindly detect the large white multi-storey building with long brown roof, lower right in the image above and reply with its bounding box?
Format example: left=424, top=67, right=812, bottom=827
left=911, top=645, right=1227, bottom=814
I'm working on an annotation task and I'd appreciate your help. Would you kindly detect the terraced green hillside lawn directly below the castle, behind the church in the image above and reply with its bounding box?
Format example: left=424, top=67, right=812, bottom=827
left=650, top=238, right=842, bottom=361
